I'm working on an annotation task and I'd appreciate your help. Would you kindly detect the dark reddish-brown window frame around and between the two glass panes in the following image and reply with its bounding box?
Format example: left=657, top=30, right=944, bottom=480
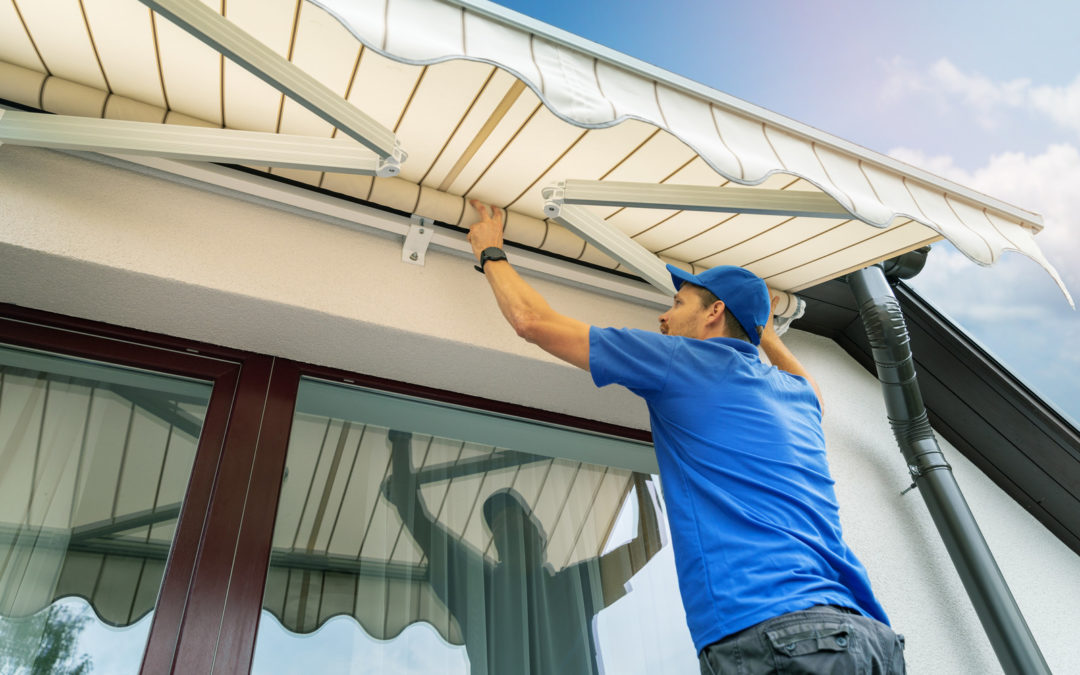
left=0, top=303, right=651, bottom=675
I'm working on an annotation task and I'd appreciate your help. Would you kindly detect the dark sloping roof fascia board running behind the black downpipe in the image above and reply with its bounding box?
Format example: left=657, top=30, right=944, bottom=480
left=794, top=280, right=1080, bottom=554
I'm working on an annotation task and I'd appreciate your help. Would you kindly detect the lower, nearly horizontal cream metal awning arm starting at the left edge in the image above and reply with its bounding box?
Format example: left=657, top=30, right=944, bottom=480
left=0, top=110, right=381, bottom=175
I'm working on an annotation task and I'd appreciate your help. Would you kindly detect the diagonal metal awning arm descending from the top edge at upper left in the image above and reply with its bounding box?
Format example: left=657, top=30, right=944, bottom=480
left=139, top=0, right=406, bottom=176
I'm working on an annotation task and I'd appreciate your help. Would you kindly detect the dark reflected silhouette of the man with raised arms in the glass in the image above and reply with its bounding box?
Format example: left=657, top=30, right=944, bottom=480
left=384, top=431, right=660, bottom=675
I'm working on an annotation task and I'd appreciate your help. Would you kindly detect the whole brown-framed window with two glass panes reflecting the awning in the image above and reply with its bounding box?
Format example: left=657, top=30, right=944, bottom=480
left=0, top=305, right=692, bottom=675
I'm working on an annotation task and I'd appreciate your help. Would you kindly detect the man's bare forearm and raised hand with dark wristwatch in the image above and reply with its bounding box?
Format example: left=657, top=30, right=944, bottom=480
left=469, top=200, right=589, bottom=370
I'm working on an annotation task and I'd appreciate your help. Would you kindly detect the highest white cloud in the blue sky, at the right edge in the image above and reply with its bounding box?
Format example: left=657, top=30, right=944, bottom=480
left=880, top=58, right=1080, bottom=134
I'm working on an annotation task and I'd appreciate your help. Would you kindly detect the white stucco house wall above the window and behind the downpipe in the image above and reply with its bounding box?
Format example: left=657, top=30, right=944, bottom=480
left=0, top=146, right=1080, bottom=674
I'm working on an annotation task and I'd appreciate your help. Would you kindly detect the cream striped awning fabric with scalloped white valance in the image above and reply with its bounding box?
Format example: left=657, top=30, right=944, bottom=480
left=0, top=0, right=1071, bottom=301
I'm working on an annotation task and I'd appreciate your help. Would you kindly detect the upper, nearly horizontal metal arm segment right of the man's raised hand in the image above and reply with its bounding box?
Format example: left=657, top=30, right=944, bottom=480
left=544, top=180, right=853, bottom=219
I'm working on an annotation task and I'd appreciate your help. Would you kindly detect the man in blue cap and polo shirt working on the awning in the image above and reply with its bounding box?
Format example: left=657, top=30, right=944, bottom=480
left=469, top=201, right=904, bottom=674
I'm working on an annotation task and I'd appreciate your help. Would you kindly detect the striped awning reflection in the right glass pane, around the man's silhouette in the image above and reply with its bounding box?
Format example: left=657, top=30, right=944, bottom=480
left=257, top=378, right=663, bottom=643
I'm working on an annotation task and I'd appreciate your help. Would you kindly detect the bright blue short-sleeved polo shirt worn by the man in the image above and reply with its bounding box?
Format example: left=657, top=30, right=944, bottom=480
left=589, top=326, right=889, bottom=651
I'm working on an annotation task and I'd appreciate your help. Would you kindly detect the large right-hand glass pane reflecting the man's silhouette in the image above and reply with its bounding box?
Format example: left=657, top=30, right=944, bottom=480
left=253, top=379, right=693, bottom=675
